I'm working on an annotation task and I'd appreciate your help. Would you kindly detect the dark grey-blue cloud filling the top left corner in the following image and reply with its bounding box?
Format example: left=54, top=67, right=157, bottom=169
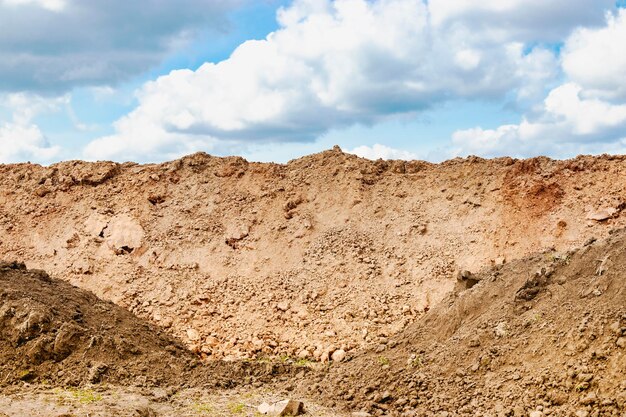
left=0, top=0, right=240, bottom=93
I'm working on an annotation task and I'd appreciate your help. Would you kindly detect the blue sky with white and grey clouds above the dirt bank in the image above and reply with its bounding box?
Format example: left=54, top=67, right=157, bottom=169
left=0, top=0, right=626, bottom=164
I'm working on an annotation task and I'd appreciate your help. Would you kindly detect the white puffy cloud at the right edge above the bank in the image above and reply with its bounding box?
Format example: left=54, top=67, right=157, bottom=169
left=452, top=10, right=626, bottom=157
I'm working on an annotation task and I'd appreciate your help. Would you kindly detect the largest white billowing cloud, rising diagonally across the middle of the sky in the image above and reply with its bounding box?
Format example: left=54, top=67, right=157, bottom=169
left=85, top=0, right=611, bottom=159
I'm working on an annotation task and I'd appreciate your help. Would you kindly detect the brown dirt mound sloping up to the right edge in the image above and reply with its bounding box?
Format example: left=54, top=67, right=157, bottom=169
left=299, top=231, right=626, bottom=417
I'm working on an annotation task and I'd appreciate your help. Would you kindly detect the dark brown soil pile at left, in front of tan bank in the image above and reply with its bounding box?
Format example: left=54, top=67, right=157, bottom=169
left=0, top=262, right=287, bottom=389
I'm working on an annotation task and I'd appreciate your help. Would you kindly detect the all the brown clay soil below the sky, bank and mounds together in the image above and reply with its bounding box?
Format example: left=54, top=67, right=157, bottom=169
left=0, top=148, right=626, bottom=417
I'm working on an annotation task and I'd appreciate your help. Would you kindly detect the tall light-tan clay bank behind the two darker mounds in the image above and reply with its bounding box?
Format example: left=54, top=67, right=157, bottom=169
left=0, top=148, right=626, bottom=359
